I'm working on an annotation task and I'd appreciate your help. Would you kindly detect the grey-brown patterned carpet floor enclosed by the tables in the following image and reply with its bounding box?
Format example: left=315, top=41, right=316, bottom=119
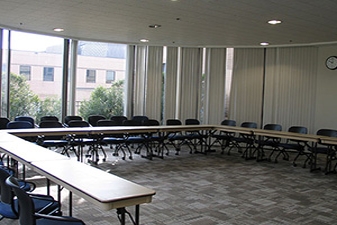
left=0, top=144, right=337, bottom=225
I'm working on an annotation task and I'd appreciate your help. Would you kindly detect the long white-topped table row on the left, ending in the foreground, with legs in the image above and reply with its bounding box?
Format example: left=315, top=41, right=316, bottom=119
left=0, top=129, right=156, bottom=224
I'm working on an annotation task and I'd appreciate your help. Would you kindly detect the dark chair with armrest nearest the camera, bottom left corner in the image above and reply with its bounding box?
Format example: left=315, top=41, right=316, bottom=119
left=6, top=176, right=84, bottom=225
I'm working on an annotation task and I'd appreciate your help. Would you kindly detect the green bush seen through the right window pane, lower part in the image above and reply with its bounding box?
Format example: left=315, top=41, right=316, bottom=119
left=79, top=81, right=123, bottom=119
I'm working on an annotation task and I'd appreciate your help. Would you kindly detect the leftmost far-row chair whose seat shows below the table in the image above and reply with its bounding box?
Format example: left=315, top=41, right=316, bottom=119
left=37, top=120, right=69, bottom=153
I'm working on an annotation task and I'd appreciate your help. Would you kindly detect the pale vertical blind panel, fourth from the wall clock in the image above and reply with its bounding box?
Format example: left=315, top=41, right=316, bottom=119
left=178, top=48, right=202, bottom=123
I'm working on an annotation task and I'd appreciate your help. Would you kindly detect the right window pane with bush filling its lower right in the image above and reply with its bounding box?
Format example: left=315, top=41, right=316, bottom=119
left=75, top=41, right=126, bottom=119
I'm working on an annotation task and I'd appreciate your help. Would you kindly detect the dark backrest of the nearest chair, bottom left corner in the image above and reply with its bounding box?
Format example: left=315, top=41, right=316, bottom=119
left=6, top=176, right=36, bottom=225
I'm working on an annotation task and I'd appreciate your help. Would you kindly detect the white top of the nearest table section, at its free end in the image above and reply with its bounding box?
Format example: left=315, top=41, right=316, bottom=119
left=32, top=160, right=155, bottom=210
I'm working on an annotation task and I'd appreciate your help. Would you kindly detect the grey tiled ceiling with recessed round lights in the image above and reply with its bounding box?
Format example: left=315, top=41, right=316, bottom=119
left=0, top=0, right=337, bottom=47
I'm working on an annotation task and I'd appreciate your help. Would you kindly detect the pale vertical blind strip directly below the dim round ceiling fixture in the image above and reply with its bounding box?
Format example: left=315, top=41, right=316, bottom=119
left=144, top=47, right=163, bottom=121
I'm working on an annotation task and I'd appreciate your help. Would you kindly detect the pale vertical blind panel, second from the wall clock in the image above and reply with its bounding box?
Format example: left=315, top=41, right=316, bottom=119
left=229, top=49, right=264, bottom=126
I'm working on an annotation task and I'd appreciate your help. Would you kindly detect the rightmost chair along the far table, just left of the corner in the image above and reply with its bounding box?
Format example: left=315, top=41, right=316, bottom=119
left=185, top=119, right=208, bottom=153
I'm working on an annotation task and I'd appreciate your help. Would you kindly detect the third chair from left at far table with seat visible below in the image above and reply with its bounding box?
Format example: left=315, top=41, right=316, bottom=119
left=97, top=120, right=132, bottom=160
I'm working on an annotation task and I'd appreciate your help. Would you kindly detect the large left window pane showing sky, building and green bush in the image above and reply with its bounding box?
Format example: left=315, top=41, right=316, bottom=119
left=10, top=31, right=63, bottom=122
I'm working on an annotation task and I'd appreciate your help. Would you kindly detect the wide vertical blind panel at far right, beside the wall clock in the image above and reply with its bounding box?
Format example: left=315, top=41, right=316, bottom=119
left=263, top=47, right=318, bottom=131
